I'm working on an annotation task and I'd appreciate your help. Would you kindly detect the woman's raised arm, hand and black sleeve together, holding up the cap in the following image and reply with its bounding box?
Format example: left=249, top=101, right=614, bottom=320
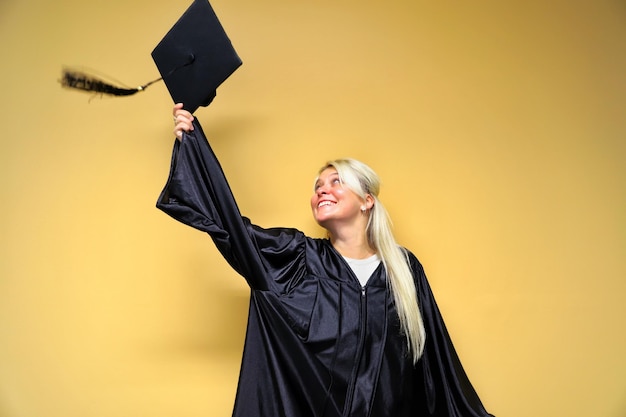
left=157, top=105, right=271, bottom=289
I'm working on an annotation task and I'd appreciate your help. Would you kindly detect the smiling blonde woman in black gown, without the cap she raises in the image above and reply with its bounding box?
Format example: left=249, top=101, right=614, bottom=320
left=157, top=104, right=490, bottom=417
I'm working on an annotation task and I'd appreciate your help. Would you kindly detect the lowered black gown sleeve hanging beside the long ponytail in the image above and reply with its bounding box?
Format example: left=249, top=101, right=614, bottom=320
left=411, top=256, right=493, bottom=417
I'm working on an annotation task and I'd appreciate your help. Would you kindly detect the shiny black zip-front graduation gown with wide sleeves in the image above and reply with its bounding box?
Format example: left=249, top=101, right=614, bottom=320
left=157, top=120, right=490, bottom=417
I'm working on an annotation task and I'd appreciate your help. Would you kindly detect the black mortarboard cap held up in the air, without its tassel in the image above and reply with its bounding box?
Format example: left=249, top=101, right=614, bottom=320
left=152, top=0, right=242, bottom=113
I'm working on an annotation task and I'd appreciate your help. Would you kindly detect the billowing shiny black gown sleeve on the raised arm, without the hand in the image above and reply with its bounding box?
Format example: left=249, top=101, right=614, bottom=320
left=157, top=119, right=304, bottom=292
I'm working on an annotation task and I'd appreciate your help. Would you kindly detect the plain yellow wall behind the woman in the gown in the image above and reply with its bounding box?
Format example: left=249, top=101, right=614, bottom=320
left=0, top=0, right=626, bottom=417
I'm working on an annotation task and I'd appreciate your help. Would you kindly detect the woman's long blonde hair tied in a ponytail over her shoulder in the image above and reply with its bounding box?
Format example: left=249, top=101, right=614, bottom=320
left=319, top=158, right=426, bottom=363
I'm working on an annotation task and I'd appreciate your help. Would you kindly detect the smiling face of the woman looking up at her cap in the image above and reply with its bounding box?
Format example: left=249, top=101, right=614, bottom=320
left=311, top=167, right=371, bottom=231
